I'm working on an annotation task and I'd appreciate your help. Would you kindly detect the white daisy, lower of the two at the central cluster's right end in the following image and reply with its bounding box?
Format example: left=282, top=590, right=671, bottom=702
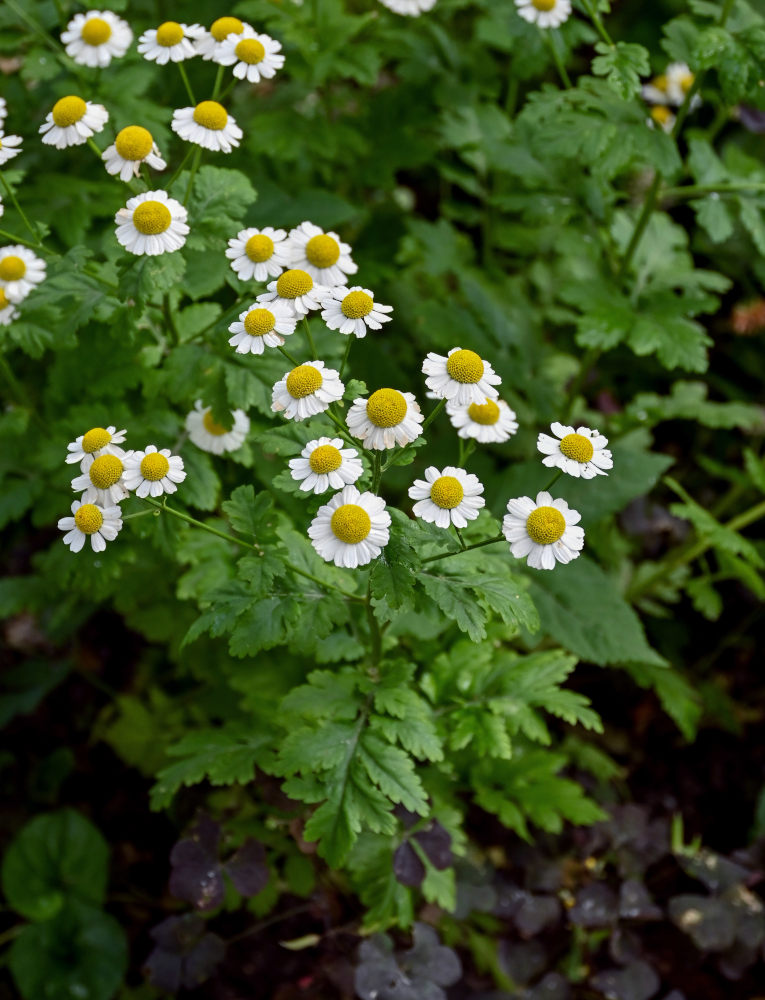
left=502, top=490, right=584, bottom=569
